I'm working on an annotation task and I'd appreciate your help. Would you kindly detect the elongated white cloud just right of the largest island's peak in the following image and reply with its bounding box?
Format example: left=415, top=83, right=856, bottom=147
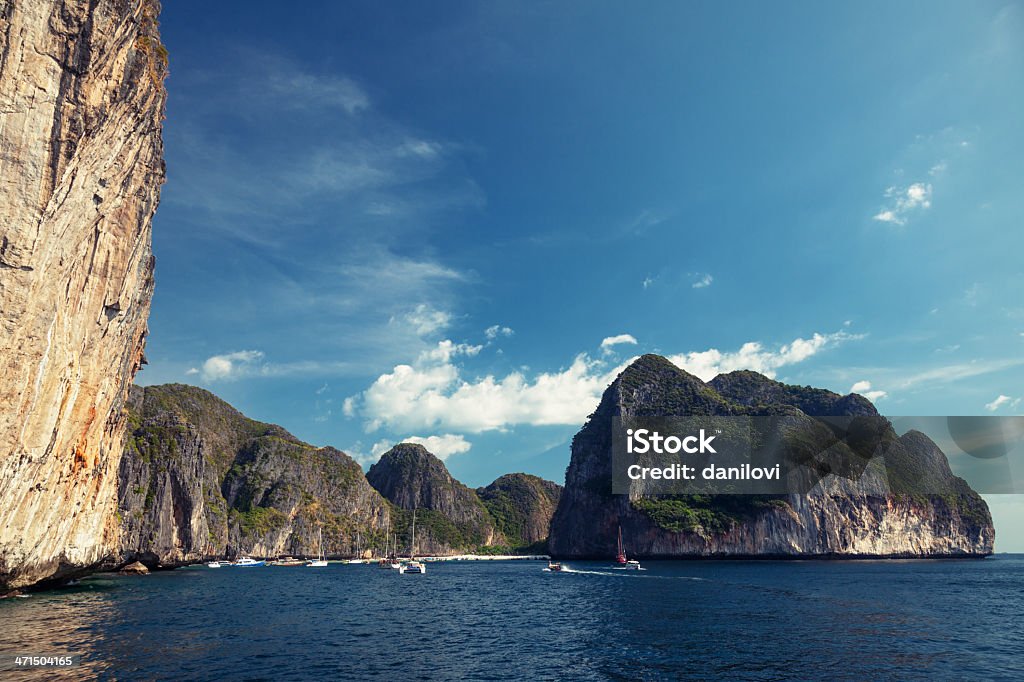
left=669, top=332, right=862, bottom=381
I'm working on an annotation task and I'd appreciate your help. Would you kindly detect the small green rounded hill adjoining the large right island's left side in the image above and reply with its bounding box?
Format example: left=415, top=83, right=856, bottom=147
left=476, top=473, right=562, bottom=552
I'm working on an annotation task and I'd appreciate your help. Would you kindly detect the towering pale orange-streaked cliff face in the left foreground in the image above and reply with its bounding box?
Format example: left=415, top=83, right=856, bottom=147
left=0, top=0, right=166, bottom=587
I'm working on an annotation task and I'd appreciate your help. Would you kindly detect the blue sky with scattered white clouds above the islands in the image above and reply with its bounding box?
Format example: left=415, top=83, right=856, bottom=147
left=138, top=0, right=1024, bottom=550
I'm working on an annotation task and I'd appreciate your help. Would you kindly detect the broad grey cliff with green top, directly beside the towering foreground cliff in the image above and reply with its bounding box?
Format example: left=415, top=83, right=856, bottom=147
left=114, top=384, right=390, bottom=567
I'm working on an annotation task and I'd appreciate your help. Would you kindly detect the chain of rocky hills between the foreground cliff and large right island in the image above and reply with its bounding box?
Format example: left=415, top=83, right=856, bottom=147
left=117, top=384, right=560, bottom=568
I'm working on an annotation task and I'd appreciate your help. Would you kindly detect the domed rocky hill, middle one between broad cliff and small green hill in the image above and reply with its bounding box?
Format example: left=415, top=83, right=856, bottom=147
left=367, top=443, right=505, bottom=555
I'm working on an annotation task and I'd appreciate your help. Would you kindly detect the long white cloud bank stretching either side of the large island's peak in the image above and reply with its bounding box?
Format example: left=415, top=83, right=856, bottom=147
left=345, top=332, right=859, bottom=433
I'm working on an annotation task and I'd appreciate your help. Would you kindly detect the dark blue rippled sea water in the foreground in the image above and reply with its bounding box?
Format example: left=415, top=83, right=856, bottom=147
left=0, top=555, right=1024, bottom=680
